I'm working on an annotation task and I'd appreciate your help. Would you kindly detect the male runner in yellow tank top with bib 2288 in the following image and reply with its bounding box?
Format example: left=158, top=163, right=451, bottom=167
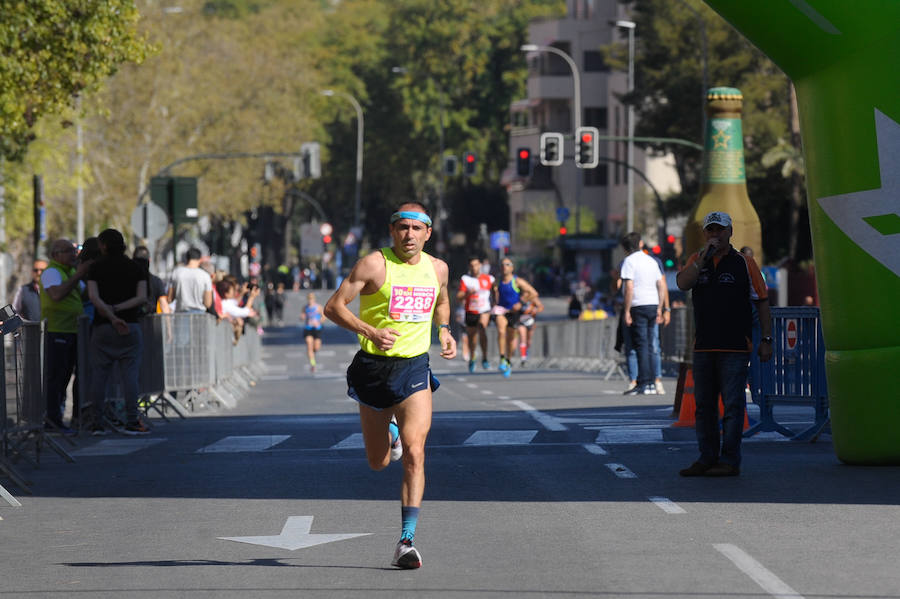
left=325, top=202, right=456, bottom=568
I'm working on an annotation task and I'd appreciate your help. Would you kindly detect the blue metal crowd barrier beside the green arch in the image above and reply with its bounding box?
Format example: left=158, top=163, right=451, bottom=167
left=744, top=306, right=829, bottom=440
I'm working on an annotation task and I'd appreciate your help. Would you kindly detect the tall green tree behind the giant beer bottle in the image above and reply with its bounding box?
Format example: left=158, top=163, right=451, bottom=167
left=606, top=0, right=809, bottom=258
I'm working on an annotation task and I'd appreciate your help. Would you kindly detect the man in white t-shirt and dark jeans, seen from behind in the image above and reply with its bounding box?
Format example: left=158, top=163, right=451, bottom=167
left=620, top=231, right=666, bottom=395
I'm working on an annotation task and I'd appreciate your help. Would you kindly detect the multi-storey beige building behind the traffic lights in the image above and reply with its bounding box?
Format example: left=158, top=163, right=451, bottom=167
left=505, top=0, right=655, bottom=283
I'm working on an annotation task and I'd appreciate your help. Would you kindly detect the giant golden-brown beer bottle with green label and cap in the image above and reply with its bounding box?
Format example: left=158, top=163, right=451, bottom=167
left=684, top=87, right=762, bottom=264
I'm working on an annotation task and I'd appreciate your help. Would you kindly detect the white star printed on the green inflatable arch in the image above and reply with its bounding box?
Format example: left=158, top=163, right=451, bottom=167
left=819, top=108, right=900, bottom=277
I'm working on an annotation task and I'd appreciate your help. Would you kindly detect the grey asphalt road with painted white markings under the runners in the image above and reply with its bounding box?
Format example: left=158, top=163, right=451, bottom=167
left=0, top=312, right=900, bottom=599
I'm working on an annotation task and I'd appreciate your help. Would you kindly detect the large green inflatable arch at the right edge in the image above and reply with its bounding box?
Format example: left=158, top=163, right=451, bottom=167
left=706, top=0, right=900, bottom=464
